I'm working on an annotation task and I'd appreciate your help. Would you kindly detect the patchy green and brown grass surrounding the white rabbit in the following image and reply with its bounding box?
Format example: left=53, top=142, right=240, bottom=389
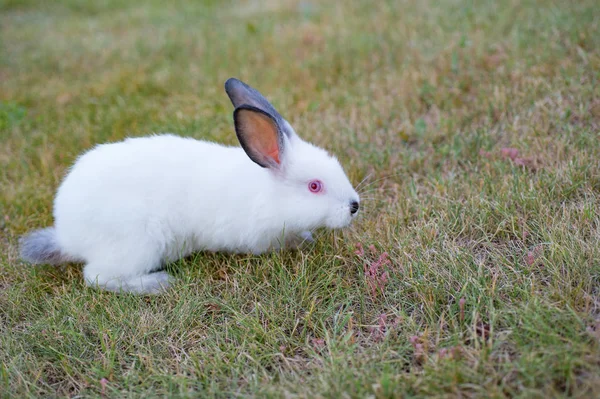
left=0, top=0, right=600, bottom=398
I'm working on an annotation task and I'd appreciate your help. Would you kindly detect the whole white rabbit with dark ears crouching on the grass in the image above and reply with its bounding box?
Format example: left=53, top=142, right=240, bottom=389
left=20, top=78, right=360, bottom=294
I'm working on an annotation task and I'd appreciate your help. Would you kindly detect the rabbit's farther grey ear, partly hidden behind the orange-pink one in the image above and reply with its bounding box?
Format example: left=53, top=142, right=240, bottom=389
left=225, top=78, right=296, bottom=138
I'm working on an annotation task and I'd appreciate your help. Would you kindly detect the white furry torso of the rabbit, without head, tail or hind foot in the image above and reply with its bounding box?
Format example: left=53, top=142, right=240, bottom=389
left=55, top=135, right=286, bottom=260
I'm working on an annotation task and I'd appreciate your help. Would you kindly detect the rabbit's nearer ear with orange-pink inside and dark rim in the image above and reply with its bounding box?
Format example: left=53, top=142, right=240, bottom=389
left=233, top=104, right=283, bottom=169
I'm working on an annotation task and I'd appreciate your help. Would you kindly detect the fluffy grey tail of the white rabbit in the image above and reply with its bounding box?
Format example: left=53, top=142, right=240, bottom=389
left=20, top=227, right=75, bottom=265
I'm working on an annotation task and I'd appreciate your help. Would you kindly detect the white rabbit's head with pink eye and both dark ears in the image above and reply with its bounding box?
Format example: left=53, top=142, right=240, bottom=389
left=225, top=78, right=359, bottom=230
